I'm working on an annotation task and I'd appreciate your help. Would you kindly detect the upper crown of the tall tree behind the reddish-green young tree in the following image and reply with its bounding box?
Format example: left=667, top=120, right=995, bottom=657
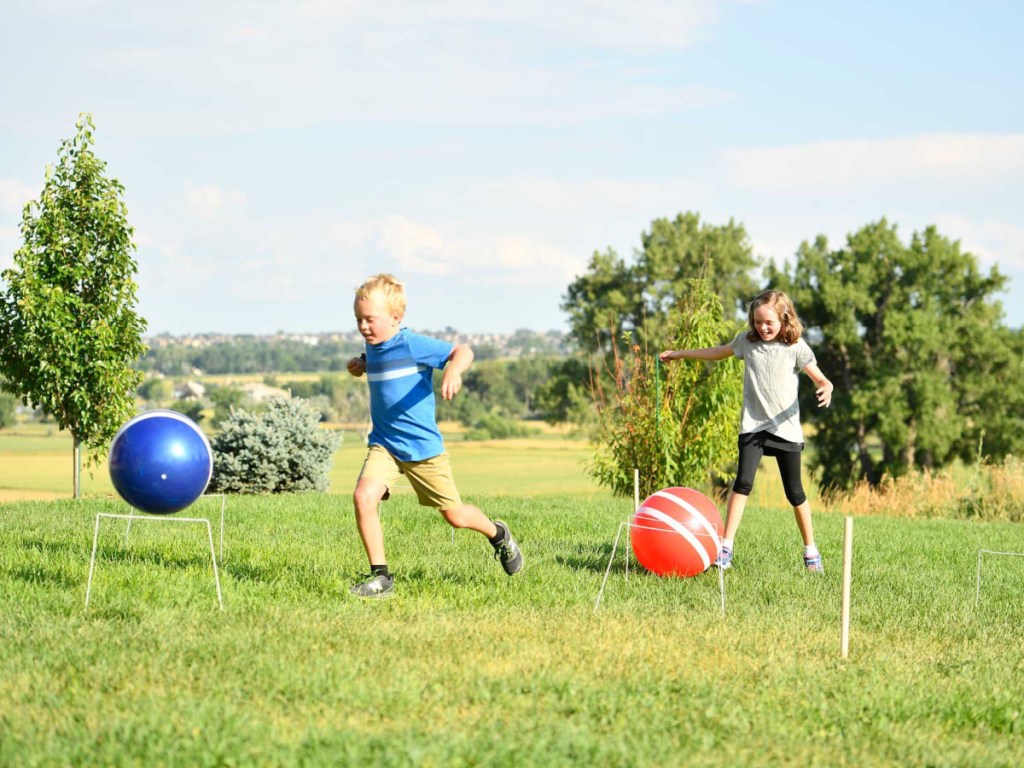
left=561, top=213, right=758, bottom=354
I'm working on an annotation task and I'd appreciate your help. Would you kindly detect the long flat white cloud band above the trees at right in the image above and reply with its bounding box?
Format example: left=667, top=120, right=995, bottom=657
left=724, top=133, right=1024, bottom=189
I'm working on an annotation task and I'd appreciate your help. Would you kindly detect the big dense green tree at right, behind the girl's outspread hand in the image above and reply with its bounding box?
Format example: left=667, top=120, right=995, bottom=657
left=768, top=219, right=1024, bottom=489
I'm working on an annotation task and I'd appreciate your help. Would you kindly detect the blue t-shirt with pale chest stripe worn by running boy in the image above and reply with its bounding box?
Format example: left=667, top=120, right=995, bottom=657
left=367, top=328, right=455, bottom=462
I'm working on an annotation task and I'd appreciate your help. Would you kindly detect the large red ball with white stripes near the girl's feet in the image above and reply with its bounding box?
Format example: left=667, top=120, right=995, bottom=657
left=630, top=487, right=725, bottom=577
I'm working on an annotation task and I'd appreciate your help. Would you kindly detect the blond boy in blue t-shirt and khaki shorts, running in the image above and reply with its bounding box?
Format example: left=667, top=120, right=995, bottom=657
left=348, top=274, right=522, bottom=598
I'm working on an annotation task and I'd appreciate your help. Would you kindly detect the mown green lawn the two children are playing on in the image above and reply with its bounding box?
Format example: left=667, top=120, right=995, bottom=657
left=0, top=494, right=1024, bottom=766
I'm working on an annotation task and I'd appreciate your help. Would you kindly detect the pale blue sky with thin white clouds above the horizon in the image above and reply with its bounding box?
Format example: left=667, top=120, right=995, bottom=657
left=0, top=0, right=1024, bottom=335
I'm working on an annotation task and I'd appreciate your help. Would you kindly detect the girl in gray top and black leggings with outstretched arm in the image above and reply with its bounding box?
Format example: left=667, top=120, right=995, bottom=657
left=658, top=291, right=833, bottom=572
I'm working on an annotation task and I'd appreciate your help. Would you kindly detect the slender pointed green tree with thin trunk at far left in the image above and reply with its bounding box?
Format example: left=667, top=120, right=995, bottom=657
left=0, top=115, right=145, bottom=498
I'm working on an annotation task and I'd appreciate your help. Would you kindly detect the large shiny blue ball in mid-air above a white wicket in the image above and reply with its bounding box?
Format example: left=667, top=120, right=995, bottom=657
left=110, top=411, right=213, bottom=515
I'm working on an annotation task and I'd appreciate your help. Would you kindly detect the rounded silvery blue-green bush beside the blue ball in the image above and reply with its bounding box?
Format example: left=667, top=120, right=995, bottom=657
left=210, top=397, right=341, bottom=494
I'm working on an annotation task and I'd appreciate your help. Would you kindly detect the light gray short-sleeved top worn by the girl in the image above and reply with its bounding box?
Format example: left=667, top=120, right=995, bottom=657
left=732, top=331, right=817, bottom=442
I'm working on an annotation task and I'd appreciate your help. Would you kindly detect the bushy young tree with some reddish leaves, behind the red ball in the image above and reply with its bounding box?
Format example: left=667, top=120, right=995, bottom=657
left=588, top=279, right=742, bottom=496
